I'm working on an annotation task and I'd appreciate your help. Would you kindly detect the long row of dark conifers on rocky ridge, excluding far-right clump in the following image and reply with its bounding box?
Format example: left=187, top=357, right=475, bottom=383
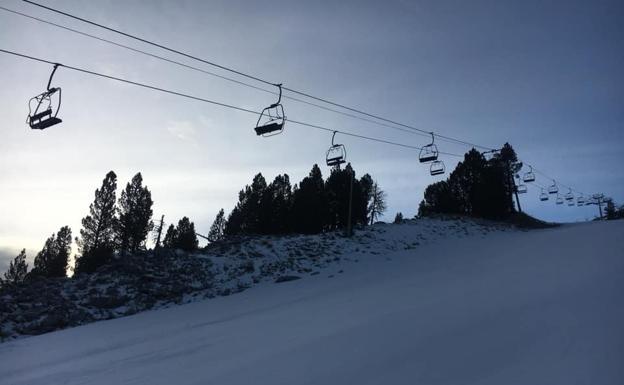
left=0, top=165, right=386, bottom=283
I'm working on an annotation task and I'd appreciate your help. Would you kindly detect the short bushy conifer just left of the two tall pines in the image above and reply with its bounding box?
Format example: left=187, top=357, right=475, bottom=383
left=30, top=226, right=72, bottom=278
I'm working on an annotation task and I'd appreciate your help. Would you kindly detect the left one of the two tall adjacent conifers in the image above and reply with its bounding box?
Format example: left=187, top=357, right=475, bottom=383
left=75, top=171, right=117, bottom=273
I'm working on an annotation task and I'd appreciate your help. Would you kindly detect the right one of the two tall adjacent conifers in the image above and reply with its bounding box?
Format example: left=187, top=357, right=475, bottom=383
left=115, top=172, right=153, bottom=255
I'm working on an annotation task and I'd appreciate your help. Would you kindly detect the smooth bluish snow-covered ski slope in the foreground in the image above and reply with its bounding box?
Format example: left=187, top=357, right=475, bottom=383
left=0, top=221, right=624, bottom=385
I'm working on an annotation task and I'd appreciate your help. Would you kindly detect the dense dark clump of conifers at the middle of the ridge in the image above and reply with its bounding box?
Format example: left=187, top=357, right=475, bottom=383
left=224, top=165, right=380, bottom=236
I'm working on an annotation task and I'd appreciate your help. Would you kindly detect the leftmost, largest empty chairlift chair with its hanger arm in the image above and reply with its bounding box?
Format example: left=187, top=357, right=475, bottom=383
left=26, top=64, right=62, bottom=130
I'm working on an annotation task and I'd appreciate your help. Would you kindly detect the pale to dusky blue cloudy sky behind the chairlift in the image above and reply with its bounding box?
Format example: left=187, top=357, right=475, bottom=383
left=0, top=0, right=624, bottom=271
